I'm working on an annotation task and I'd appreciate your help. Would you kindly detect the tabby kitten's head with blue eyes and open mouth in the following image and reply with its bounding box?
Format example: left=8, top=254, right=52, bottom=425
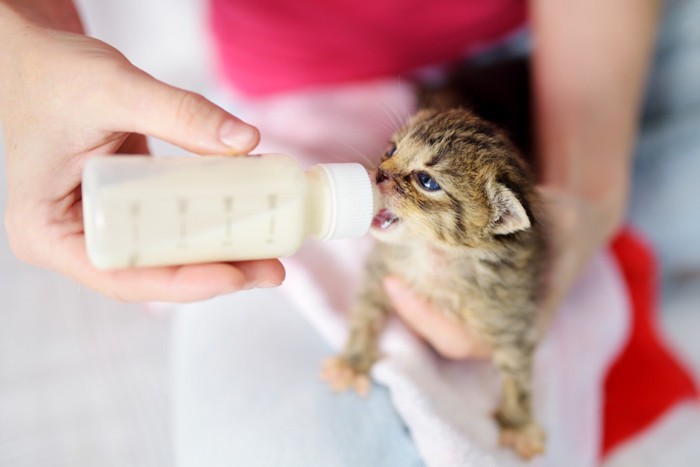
left=372, top=109, right=534, bottom=247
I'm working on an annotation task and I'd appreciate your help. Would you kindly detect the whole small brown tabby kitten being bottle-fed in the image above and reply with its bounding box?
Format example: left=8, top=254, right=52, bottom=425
left=323, top=109, right=545, bottom=458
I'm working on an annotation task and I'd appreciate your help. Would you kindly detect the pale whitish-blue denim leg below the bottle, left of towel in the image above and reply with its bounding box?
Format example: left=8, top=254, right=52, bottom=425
left=173, top=290, right=424, bottom=467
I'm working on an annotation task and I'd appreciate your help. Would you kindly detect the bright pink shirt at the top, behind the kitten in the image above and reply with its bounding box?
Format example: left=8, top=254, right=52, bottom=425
left=210, top=0, right=526, bottom=96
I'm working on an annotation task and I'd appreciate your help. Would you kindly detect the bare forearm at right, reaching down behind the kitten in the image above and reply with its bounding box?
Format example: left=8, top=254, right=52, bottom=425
left=531, top=0, right=660, bottom=328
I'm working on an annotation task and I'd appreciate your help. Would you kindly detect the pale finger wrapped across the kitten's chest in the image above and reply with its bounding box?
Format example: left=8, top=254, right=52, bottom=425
left=383, top=276, right=491, bottom=360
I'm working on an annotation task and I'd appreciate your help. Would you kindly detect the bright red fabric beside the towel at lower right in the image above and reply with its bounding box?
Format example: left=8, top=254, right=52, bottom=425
left=601, top=231, right=698, bottom=457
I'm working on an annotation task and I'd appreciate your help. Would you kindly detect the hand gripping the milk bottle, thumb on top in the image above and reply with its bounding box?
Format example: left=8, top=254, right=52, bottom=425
left=0, top=5, right=284, bottom=302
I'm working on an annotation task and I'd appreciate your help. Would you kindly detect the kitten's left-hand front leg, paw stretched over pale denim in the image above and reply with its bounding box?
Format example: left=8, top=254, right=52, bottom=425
left=321, top=281, right=389, bottom=396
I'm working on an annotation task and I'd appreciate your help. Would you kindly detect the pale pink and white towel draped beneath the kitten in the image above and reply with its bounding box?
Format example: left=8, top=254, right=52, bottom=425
left=284, top=241, right=628, bottom=467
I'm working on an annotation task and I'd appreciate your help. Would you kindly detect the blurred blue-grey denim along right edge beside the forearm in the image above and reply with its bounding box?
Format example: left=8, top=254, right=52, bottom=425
left=629, top=0, right=700, bottom=281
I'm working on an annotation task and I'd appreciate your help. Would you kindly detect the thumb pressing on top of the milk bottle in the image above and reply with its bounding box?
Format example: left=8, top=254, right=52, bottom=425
left=112, top=69, right=260, bottom=154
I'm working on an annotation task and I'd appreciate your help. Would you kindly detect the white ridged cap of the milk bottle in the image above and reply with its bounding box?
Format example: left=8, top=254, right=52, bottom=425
left=319, top=163, right=375, bottom=240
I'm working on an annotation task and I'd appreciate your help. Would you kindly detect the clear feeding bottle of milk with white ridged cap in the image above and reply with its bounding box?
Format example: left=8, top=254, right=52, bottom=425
left=83, top=154, right=375, bottom=269
